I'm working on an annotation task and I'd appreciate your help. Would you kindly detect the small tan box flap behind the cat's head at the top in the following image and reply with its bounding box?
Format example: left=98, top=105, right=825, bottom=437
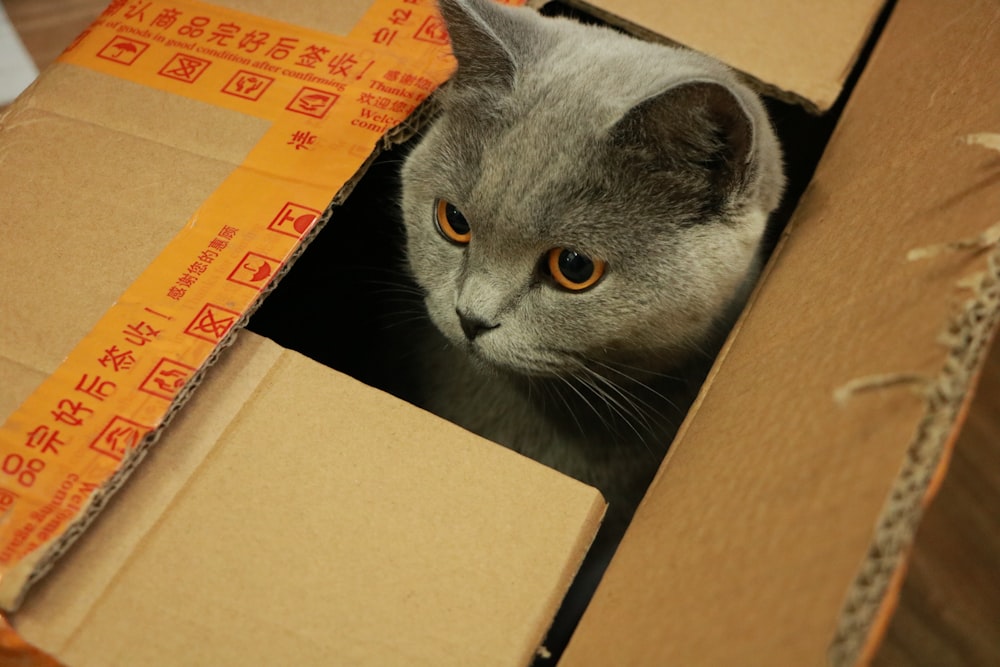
left=569, top=0, right=885, bottom=112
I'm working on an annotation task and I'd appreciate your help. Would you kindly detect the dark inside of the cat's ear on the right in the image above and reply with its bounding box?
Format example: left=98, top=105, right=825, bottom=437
left=613, top=81, right=754, bottom=195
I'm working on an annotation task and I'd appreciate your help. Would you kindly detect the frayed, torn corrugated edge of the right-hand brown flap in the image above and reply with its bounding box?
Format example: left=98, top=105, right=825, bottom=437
left=827, top=133, right=1000, bottom=667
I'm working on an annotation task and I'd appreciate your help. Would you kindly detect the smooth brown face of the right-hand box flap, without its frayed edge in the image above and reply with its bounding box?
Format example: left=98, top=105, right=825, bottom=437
left=563, top=0, right=1000, bottom=666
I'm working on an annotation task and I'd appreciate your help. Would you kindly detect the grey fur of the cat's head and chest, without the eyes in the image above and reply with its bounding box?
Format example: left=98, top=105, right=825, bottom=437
left=403, top=0, right=784, bottom=525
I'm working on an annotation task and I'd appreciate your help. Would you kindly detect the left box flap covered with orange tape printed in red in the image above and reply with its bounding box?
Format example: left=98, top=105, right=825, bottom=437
left=0, top=1, right=464, bottom=609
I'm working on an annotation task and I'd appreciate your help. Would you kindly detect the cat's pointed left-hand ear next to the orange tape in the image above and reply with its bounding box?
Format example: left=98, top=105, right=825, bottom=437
left=438, top=0, right=523, bottom=90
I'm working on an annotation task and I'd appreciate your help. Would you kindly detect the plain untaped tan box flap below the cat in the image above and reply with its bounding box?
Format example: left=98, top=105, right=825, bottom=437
left=15, top=332, right=604, bottom=667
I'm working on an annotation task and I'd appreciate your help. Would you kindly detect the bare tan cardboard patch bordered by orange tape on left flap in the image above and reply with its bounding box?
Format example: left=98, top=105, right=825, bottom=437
left=0, top=73, right=250, bottom=378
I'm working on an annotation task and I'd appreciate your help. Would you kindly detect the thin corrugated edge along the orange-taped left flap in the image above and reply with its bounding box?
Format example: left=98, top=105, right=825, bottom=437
left=0, top=92, right=437, bottom=612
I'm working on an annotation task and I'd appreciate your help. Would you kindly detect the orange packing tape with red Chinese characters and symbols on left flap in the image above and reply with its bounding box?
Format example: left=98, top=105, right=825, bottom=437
left=0, top=0, right=524, bottom=610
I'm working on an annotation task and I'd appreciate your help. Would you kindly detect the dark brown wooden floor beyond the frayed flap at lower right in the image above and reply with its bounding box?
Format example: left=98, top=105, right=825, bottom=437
left=870, top=330, right=1000, bottom=667
